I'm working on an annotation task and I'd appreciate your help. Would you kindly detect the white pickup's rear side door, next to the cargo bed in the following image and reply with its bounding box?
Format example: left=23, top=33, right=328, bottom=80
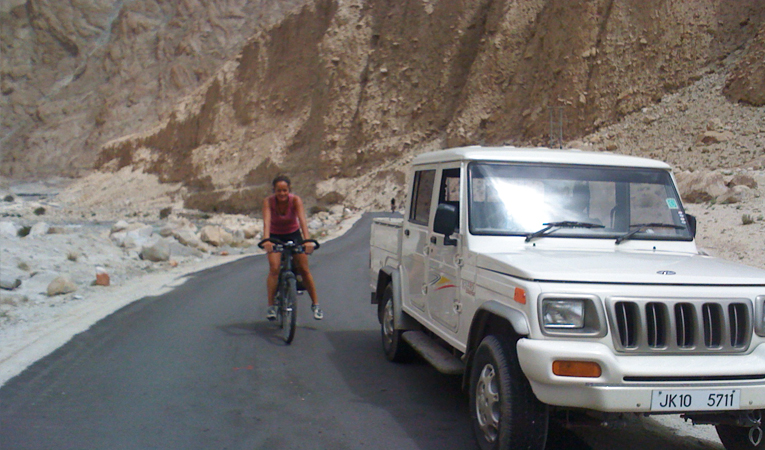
left=401, top=168, right=436, bottom=312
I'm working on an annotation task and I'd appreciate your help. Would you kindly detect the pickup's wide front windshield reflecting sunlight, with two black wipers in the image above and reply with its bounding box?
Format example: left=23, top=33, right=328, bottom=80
left=468, top=163, right=692, bottom=241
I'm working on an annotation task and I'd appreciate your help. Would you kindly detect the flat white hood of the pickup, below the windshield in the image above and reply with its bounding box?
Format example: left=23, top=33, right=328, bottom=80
left=477, top=249, right=765, bottom=286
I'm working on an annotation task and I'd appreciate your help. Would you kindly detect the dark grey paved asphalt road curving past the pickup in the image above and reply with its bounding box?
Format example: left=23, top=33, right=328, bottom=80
left=0, top=215, right=721, bottom=450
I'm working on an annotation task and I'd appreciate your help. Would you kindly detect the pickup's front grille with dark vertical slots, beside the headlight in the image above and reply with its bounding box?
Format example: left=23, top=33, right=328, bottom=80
left=608, top=298, right=753, bottom=353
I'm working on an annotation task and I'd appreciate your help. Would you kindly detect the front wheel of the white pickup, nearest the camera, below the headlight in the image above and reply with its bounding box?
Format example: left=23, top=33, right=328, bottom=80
left=470, top=335, right=548, bottom=450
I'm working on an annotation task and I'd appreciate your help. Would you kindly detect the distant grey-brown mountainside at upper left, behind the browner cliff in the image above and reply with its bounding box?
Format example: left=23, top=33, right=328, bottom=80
left=0, top=0, right=303, bottom=177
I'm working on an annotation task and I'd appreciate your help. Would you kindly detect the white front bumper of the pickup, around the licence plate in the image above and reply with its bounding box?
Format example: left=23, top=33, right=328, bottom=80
left=517, top=339, right=765, bottom=413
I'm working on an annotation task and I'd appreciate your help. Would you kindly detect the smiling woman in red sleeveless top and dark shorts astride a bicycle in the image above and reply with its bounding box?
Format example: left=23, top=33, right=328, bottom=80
left=263, top=175, right=324, bottom=320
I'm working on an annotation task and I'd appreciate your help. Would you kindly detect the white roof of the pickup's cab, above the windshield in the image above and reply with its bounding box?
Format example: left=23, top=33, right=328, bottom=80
left=412, top=146, right=671, bottom=170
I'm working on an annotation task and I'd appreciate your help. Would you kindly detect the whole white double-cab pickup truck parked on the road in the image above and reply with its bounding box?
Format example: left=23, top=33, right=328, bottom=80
left=370, top=147, right=765, bottom=450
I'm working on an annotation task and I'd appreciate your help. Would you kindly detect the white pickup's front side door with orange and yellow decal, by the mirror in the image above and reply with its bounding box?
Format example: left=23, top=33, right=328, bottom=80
left=426, top=166, right=463, bottom=332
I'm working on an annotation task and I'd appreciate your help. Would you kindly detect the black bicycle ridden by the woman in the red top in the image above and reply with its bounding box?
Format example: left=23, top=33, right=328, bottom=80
left=258, top=238, right=320, bottom=344
